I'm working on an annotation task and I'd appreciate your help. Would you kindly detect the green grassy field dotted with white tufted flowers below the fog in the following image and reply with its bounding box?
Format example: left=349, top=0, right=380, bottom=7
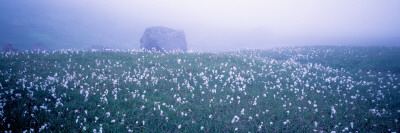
left=0, top=46, right=400, bottom=132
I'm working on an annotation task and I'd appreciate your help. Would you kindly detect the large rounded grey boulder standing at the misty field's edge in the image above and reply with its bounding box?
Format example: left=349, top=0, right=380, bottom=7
left=140, top=26, right=187, bottom=51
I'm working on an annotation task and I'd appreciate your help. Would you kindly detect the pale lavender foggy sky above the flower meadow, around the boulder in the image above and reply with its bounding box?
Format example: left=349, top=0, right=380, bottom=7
left=0, top=0, right=400, bottom=50
